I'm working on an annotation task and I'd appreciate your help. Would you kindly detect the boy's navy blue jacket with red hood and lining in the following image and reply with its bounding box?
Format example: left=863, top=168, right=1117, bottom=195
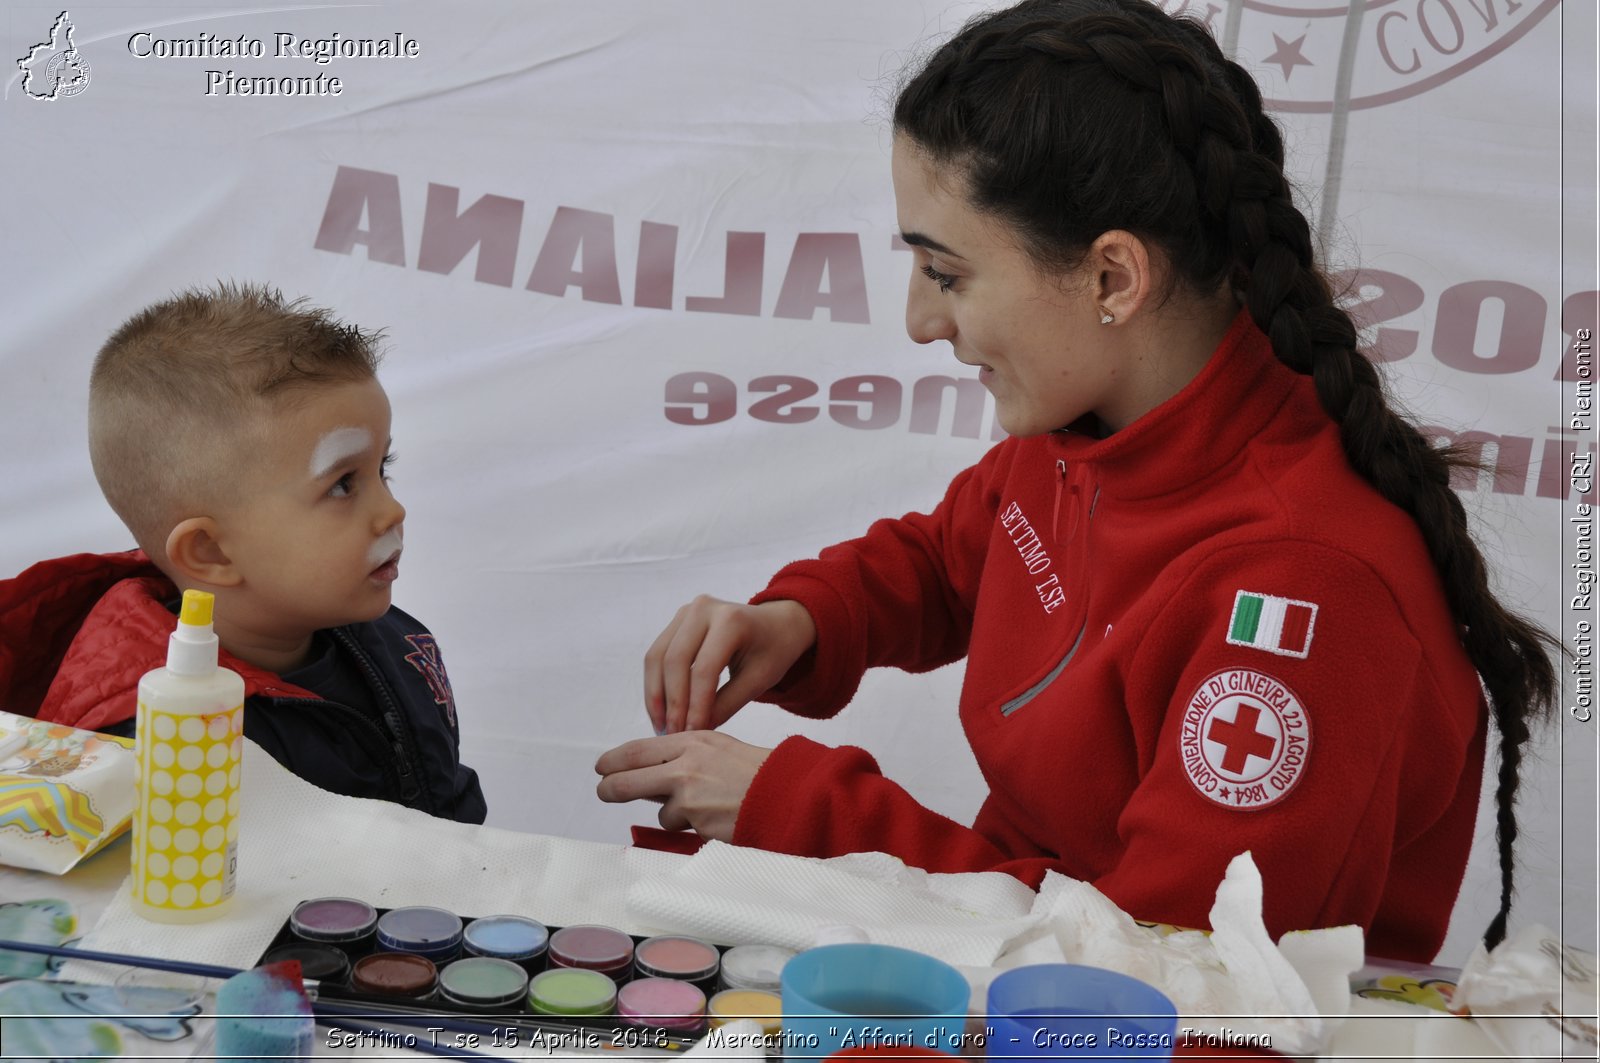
left=0, top=551, right=488, bottom=823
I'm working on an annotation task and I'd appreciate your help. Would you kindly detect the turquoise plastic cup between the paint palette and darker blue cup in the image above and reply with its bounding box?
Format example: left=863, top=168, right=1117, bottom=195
left=781, top=945, right=971, bottom=1060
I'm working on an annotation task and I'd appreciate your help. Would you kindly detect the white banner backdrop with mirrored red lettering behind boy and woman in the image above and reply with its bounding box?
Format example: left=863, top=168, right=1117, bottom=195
left=0, top=0, right=1597, bottom=962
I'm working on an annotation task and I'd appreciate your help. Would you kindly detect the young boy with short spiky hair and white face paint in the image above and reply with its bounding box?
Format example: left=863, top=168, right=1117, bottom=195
left=0, top=285, right=486, bottom=823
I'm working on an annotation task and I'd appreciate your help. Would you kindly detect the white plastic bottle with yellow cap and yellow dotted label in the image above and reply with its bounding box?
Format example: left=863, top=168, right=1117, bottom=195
left=133, top=591, right=245, bottom=922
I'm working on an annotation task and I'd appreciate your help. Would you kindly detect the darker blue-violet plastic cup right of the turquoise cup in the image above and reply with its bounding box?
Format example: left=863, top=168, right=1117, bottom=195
left=986, top=964, right=1178, bottom=1060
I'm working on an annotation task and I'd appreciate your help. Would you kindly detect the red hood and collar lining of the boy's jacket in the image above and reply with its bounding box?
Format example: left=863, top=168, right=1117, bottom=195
left=0, top=551, right=317, bottom=730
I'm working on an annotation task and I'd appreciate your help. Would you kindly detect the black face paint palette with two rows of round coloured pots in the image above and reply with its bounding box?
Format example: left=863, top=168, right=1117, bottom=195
left=258, top=897, right=776, bottom=1050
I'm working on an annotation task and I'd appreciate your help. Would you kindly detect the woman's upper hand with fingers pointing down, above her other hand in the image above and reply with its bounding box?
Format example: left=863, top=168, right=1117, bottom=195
left=640, top=594, right=816, bottom=736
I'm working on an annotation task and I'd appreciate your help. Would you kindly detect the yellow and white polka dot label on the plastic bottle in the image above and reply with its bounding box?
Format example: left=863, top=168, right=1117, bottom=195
left=133, top=701, right=245, bottom=914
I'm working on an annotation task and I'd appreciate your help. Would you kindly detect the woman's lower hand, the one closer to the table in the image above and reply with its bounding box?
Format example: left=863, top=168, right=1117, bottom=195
left=595, top=730, right=771, bottom=842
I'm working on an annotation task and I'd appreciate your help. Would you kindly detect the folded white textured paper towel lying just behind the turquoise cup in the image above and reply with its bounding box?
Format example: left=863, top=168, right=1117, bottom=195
left=627, top=842, right=1037, bottom=967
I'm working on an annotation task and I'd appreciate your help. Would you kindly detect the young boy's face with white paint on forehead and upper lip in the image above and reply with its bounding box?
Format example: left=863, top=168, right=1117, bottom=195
left=216, top=379, right=405, bottom=639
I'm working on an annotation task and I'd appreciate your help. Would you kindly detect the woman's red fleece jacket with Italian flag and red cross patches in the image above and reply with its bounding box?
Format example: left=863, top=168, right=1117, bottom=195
left=733, top=314, right=1486, bottom=961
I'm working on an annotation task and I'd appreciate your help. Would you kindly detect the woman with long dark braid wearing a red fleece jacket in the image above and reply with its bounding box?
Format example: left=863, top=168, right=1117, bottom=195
left=597, top=0, right=1554, bottom=961
